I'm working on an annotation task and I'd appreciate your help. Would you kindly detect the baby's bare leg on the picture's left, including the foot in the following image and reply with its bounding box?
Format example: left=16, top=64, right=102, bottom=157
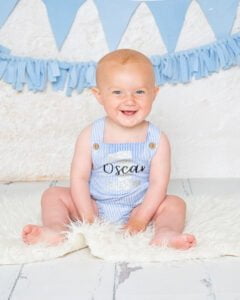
left=22, top=187, right=80, bottom=245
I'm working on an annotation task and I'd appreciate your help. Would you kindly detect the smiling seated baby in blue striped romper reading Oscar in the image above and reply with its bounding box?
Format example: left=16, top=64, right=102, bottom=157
left=22, top=49, right=196, bottom=249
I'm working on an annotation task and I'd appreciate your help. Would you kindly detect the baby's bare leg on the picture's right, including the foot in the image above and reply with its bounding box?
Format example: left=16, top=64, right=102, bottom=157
left=151, top=195, right=196, bottom=249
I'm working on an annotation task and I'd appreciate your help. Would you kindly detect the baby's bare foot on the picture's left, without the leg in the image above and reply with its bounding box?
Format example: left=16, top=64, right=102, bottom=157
left=22, top=224, right=65, bottom=245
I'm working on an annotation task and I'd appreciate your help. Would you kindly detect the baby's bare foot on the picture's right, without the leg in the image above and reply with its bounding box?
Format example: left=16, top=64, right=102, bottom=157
left=150, top=231, right=196, bottom=250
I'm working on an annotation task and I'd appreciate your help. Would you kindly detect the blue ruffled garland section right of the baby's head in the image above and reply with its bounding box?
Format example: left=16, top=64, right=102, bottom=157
left=151, top=33, right=240, bottom=85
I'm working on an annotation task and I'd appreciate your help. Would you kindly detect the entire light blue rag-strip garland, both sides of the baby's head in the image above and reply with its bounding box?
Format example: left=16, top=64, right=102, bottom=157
left=0, top=33, right=240, bottom=96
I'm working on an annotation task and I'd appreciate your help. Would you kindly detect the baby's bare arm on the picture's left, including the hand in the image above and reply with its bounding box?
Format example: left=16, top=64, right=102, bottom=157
left=70, top=126, right=96, bottom=223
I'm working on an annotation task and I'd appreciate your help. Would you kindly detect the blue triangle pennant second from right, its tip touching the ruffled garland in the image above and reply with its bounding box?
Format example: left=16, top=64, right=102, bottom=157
left=146, top=0, right=192, bottom=52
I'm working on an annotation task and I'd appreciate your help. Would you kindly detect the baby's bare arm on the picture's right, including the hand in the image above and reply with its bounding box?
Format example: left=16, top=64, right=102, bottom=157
left=125, top=133, right=171, bottom=232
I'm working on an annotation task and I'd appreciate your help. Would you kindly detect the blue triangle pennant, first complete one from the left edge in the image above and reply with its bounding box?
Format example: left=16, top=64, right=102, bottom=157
left=43, top=0, right=86, bottom=49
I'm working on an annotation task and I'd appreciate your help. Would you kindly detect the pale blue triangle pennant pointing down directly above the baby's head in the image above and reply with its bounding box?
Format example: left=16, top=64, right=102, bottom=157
left=94, top=0, right=140, bottom=51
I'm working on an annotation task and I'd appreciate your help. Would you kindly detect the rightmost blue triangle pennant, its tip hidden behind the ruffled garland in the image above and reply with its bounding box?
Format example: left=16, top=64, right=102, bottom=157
left=197, top=0, right=239, bottom=39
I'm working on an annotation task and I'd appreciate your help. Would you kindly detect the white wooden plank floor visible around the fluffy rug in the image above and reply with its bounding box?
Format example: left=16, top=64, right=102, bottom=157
left=0, top=179, right=240, bottom=300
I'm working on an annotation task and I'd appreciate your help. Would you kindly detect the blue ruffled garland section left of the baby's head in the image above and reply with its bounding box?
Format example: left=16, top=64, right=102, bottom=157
left=0, top=46, right=96, bottom=96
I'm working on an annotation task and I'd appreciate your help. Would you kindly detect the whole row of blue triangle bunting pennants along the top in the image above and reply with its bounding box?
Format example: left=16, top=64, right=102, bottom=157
left=0, top=0, right=240, bottom=53
